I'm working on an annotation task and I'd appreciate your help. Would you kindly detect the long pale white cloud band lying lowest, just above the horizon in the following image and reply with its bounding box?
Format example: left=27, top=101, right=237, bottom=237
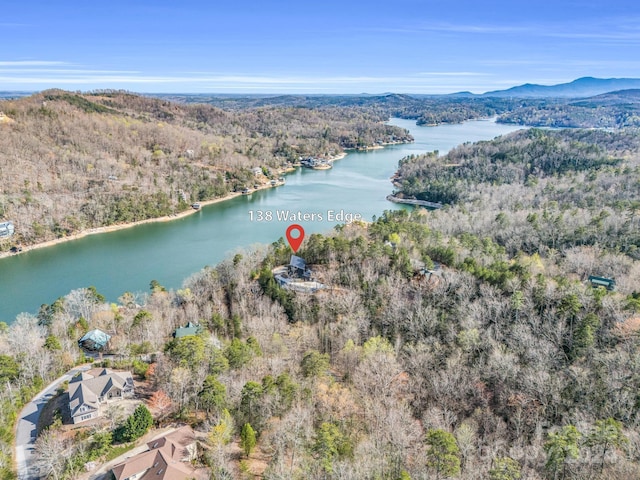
left=0, top=68, right=632, bottom=94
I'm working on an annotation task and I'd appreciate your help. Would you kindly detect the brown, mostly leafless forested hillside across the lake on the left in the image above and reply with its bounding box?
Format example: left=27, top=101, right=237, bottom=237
left=0, top=90, right=412, bottom=250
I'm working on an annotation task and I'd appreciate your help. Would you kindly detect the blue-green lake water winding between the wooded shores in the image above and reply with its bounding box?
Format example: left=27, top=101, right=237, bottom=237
left=0, top=118, right=521, bottom=323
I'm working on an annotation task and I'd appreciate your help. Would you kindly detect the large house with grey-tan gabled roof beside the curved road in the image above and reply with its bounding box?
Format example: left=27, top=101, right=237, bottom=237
left=69, top=368, right=133, bottom=423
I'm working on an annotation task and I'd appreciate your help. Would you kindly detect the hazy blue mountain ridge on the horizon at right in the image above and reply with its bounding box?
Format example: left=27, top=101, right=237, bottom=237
left=478, top=77, right=640, bottom=98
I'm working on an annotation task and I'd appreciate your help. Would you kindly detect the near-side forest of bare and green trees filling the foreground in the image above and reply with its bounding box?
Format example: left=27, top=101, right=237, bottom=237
left=0, top=124, right=640, bottom=480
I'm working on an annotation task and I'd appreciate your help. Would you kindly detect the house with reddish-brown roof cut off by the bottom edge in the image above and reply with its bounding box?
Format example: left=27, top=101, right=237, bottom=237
left=111, top=426, right=198, bottom=480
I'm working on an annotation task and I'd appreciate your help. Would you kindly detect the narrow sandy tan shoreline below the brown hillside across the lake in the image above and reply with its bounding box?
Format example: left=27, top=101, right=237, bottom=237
left=0, top=152, right=348, bottom=260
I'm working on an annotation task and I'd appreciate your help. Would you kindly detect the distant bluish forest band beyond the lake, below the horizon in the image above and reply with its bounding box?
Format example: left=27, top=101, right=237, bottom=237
left=162, top=90, right=640, bottom=128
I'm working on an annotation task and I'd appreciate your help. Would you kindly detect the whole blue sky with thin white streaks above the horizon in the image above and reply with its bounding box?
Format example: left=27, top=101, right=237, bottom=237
left=0, top=0, right=640, bottom=93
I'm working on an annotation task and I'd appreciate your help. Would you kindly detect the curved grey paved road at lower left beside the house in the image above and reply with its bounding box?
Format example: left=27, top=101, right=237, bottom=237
left=15, top=364, right=91, bottom=480
